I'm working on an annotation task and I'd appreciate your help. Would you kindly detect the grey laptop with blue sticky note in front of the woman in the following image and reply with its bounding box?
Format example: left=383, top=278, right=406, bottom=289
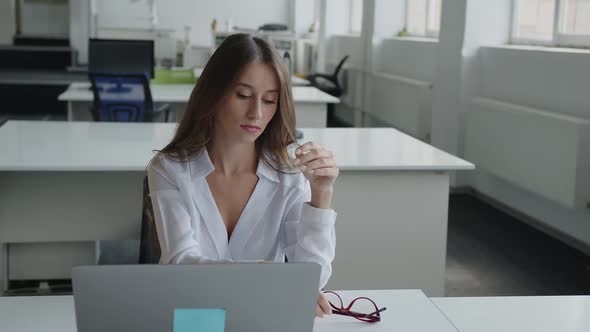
left=72, top=263, right=320, bottom=332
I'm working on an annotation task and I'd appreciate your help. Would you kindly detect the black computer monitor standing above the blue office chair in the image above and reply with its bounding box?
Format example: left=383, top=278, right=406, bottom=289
left=88, top=38, right=155, bottom=78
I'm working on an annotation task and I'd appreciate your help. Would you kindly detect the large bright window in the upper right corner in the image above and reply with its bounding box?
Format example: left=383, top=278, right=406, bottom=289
left=512, top=0, right=590, bottom=47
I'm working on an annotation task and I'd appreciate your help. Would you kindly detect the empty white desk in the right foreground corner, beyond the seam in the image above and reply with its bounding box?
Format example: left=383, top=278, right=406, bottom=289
left=432, top=296, right=590, bottom=332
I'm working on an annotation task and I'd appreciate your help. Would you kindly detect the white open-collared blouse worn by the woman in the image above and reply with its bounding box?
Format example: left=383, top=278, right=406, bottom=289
left=148, top=149, right=336, bottom=288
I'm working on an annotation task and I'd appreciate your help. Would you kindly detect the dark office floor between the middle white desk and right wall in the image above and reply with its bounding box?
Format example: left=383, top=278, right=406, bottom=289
left=446, top=194, right=590, bottom=296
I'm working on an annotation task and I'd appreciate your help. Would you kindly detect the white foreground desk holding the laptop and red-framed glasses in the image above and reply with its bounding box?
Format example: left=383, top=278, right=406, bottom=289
left=0, top=290, right=457, bottom=332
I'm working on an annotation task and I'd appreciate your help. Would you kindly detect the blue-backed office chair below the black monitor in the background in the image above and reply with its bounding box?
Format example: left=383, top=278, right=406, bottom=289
left=89, top=73, right=170, bottom=122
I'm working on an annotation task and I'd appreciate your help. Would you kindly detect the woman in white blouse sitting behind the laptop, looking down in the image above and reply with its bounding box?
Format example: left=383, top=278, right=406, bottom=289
left=148, top=34, right=339, bottom=317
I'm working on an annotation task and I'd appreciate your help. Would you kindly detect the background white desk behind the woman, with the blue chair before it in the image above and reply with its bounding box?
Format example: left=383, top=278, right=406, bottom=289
left=57, top=82, right=340, bottom=128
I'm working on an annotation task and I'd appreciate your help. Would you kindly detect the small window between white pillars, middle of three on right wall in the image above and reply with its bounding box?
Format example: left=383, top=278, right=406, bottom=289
left=406, top=0, right=442, bottom=37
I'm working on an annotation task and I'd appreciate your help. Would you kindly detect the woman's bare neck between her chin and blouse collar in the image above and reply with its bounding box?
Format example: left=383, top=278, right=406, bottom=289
left=207, top=140, right=258, bottom=176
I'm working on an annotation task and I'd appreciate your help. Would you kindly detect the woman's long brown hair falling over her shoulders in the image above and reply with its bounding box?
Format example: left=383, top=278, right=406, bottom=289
left=156, top=33, right=296, bottom=171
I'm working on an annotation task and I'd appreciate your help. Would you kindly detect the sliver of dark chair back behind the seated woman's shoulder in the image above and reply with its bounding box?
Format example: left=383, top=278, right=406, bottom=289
left=138, top=176, right=162, bottom=264
